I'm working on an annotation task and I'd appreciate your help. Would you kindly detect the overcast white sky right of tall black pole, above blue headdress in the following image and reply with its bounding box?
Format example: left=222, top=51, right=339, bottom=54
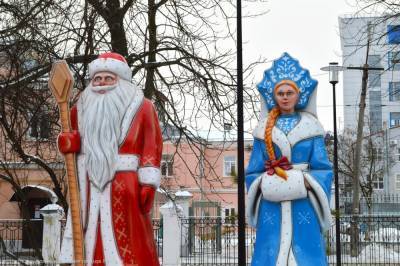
left=242, top=0, right=356, bottom=131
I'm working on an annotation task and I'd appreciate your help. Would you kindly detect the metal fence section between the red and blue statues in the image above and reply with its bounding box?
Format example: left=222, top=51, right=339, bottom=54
left=181, top=217, right=255, bottom=266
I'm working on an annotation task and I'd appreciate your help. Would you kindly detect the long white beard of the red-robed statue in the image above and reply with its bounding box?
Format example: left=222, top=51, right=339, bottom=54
left=81, top=79, right=136, bottom=190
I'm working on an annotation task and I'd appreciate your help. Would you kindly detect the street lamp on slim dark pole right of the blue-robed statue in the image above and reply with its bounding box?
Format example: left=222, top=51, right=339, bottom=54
left=321, top=62, right=344, bottom=266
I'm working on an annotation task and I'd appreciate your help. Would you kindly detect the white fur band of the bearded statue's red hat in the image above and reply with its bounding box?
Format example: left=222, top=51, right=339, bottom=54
left=89, top=58, right=132, bottom=81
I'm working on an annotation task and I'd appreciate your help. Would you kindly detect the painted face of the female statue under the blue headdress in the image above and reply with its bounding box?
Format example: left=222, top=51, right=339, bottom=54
left=275, top=84, right=299, bottom=114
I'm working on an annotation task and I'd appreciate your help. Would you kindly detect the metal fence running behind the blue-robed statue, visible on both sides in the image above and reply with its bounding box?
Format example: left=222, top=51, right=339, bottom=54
left=181, top=216, right=400, bottom=266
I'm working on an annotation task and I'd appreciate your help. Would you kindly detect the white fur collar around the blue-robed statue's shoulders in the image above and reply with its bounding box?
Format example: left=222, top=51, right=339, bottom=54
left=253, top=112, right=325, bottom=151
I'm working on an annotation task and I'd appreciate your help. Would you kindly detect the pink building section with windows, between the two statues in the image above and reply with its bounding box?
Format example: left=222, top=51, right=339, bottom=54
left=156, top=136, right=252, bottom=219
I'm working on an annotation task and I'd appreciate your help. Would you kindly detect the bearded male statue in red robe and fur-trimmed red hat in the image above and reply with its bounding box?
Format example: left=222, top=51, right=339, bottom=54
left=58, top=52, right=162, bottom=266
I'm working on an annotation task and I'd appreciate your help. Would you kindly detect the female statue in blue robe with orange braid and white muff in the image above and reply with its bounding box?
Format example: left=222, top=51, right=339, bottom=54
left=246, top=53, right=332, bottom=266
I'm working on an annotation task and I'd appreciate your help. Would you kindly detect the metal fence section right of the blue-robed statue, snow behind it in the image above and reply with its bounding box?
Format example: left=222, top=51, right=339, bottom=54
left=327, top=216, right=400, bottom=265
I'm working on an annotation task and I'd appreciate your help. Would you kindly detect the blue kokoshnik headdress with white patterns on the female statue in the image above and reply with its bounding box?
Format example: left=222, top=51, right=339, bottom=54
left=257, top=53, right=318, bottom=111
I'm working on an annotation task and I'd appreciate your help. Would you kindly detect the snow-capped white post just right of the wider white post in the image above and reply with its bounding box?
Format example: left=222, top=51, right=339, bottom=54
left=175, top=190, right=193, bottom=256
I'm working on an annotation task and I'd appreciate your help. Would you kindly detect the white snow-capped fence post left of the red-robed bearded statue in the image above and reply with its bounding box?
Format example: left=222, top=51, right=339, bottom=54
left=40, top=203, right=64, bottom=265
